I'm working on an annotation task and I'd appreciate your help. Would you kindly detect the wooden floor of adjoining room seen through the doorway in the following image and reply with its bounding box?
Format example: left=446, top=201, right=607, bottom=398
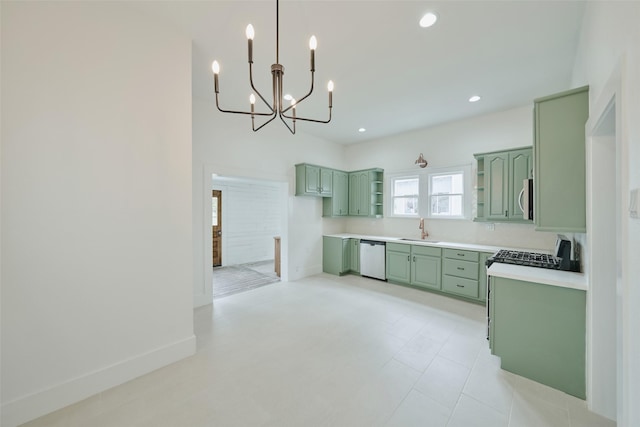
left=213, top=260, right=280, bottom=299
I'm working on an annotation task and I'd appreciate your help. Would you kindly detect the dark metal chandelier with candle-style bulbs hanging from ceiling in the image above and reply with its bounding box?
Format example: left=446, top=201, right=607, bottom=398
left=211, top=0, right=333, bottom=134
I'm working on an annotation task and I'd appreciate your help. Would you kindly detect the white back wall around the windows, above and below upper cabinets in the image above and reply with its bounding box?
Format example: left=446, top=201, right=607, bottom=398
left=346, top=105, right=556, bottom=250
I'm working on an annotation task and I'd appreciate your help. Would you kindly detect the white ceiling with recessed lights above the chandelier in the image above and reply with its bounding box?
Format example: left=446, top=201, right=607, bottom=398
left=134, top=0, right=584, bottom=144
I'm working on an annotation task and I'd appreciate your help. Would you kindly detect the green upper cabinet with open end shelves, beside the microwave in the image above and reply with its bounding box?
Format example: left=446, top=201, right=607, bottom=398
left=474, top=147, right=533, bottom=223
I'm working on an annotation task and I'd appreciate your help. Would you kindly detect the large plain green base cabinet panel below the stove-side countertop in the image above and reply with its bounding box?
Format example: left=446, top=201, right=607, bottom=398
left=489, top=276, right=586, bottom=399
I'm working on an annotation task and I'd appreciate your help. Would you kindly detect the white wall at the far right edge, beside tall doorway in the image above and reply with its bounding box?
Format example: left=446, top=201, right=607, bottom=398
left=573, top=2, right=640, bottom=426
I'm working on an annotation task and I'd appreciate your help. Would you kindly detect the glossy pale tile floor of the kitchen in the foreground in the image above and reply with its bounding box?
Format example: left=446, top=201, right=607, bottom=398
left=21, top=274, right=615, bottom=427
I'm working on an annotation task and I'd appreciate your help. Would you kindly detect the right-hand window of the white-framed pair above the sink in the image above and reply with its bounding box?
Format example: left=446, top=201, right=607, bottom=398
left=428, top=171, right=464, bottom=218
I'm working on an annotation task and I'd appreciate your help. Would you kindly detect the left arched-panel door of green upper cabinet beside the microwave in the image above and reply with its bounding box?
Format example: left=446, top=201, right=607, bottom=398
left=484, top=153, right=509, bottom=219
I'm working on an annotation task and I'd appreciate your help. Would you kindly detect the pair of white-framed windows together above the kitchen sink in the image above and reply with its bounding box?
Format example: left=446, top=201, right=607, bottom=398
left=388, top=165, right=471, bottom=219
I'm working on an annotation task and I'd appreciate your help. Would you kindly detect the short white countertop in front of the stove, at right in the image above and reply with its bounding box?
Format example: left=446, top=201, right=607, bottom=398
left=487, top=262, right=588, bottom=291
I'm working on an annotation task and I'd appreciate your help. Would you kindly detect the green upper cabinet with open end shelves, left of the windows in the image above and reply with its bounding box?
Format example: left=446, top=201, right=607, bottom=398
left=349, top=169, right=384, bottom=218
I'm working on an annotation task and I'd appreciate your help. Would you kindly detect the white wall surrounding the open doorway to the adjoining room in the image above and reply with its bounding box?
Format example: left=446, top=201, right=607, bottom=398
left=193, top=95, right=345, bottom=306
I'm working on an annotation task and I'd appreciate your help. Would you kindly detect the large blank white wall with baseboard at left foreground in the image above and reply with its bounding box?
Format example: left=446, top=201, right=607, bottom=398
left=1, top=2, right=195, bottom=426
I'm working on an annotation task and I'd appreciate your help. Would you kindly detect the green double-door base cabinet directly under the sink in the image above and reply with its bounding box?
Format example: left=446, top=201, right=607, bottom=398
left=386, top=243, right=442, bottom=289
